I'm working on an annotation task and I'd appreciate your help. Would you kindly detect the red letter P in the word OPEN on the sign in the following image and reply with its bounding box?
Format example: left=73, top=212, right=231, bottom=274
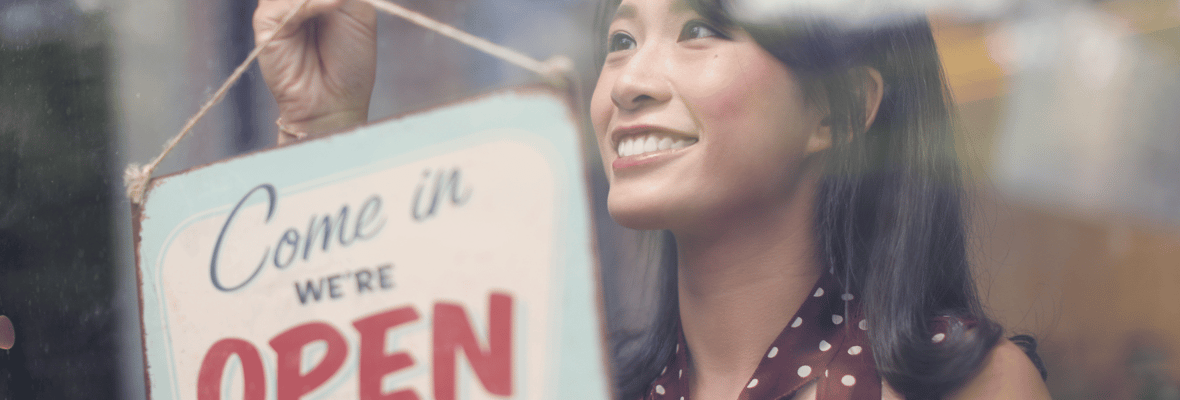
left=270, top=322, right=348, bottom=400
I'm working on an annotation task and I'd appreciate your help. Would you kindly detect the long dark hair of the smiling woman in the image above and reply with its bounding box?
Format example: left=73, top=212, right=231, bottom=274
left=598, top=0, right=1002, bottom=400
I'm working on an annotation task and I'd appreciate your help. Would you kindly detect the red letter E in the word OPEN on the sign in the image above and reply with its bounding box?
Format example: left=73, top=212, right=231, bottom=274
left=353, top=306, right=419, bottom=400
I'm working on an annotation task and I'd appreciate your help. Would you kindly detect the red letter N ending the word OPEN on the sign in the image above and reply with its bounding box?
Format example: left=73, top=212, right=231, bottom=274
left=433, top=293, right=512, bottom=400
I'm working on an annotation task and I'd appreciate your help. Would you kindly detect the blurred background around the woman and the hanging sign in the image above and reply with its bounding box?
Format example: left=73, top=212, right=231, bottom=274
left=0, top=0, right=1180, bottom=399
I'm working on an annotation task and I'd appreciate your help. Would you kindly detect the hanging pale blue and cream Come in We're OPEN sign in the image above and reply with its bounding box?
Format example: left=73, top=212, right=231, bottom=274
left=135, top=88, right=609, bottom=400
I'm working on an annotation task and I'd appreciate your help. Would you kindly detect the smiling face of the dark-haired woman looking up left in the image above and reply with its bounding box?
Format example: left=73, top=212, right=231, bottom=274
left=590, top=0, right=830, bottom=231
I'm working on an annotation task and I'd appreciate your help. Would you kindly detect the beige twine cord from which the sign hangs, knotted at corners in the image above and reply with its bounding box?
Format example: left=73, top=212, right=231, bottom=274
left=123, top=0, right=573, bottom=205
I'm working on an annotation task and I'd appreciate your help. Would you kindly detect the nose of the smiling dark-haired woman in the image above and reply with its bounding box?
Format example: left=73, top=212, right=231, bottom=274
left=610, top=47, right=671, bottom=111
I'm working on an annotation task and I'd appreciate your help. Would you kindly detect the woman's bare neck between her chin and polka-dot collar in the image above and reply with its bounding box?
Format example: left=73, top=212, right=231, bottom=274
left=676, top=176, right=821, bottom=400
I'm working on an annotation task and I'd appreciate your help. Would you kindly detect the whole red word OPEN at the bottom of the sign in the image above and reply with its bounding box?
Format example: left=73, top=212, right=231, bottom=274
left=197, top=293, right=512, bottom=400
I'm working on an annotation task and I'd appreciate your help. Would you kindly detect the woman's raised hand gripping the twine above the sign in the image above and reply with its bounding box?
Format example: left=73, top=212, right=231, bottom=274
left=254, top=0, right=376, bottom=143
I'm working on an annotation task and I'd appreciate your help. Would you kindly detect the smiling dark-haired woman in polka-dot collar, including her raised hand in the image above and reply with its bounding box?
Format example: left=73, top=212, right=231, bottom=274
left=255, top=0, right=1048, bottom=399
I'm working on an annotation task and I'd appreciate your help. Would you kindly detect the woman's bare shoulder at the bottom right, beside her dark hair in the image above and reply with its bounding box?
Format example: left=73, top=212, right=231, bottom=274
left=946, top=340, right=1050, bottom=400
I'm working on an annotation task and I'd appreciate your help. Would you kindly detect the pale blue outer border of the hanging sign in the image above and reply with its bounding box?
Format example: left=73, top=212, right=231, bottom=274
left=136, top=88, right=610, bottom=399
